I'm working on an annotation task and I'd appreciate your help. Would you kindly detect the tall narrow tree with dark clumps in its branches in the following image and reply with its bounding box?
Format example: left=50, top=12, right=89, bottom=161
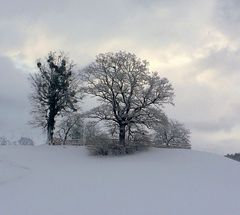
left=30, top=52, right=78, bottom=144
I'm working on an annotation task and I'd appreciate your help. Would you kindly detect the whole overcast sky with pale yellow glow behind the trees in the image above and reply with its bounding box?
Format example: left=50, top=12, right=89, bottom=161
left=0, top=0, right=240, bottom=154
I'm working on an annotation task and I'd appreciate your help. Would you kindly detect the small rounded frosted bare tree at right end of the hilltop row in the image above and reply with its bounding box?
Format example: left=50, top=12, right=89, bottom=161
left=154, top=120, right=191, bottom=148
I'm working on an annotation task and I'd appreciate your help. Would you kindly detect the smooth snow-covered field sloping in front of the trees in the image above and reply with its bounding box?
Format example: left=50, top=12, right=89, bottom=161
left=0, top=146, right=240, bottom=215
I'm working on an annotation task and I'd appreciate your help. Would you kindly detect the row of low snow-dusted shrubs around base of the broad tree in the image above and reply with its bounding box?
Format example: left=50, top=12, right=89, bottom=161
left=53, top=116, right=191, bottom=155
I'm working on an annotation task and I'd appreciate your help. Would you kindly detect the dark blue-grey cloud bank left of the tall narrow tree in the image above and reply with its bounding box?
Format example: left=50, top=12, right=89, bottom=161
left=0, top=57, right=34, bottom=136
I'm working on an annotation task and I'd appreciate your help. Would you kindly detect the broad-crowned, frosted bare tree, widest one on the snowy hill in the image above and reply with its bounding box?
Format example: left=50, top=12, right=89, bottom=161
left=82, top=51, right=174, bottom=145
